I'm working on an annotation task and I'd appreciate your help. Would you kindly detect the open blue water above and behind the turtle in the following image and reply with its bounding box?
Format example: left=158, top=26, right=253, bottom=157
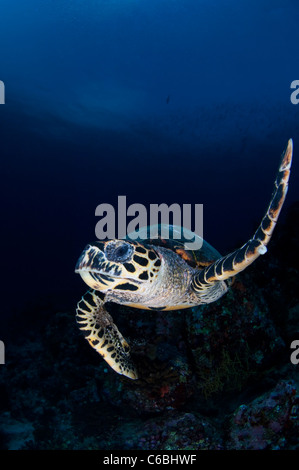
left=0, top=0, right=299, bottom=328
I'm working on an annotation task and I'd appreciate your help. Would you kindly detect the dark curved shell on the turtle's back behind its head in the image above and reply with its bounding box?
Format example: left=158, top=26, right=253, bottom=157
left=126, top=224, right=221, bottom=268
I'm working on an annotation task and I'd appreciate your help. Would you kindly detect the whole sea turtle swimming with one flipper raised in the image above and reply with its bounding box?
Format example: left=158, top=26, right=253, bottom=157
left=75, top=139, right=293, bottom=379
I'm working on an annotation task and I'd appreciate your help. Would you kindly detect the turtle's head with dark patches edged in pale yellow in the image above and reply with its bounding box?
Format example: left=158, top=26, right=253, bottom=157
left=75, top=240, right=161, bottom=292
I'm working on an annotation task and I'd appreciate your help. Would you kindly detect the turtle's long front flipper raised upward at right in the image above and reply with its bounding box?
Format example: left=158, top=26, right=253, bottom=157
left=192, top=139, right=293, bottom=297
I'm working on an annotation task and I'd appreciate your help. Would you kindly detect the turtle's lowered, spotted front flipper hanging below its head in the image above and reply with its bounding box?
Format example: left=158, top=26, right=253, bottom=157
left=76, top=290, right=138, bottom=379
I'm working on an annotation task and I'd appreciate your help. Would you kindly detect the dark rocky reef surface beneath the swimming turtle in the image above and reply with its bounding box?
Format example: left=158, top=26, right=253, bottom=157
left=0, top=203, right=299, bottom=450
